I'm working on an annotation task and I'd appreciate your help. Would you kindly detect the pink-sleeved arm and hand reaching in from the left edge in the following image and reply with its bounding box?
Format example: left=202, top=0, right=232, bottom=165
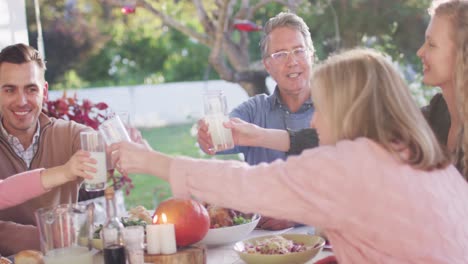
left=0, top=150, right=96, bottom=209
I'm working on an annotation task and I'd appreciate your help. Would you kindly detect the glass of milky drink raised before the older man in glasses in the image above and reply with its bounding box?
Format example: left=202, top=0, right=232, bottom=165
left=203, top=90, right=234, bottom=152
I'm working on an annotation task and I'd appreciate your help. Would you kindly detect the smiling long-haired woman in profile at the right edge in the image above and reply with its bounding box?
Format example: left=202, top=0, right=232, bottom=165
left=418, top=0, right=468, bottom=179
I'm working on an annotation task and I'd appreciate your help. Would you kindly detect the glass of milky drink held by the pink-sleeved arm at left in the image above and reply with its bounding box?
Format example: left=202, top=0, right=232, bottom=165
left=80, top=131, right=107, bottom=192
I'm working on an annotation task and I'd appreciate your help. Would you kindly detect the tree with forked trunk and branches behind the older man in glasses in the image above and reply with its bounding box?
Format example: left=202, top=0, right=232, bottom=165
left=133, top=0, right=303, bottom=96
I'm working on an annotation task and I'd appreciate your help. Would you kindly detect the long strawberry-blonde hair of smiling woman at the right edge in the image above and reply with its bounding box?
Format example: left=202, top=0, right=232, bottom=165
left=429, top=0, right=468, bottom=179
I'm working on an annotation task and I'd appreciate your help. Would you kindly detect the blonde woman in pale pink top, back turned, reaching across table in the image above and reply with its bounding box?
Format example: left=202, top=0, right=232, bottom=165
left=111, top=49, right=468, bottom=264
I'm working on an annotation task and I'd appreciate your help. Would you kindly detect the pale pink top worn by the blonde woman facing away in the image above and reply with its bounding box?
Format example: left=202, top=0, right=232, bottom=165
left=170, top=138, right=468, bottom=264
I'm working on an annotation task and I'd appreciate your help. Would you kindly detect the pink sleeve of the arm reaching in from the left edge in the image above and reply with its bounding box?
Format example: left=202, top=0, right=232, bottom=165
left=0, top=169, right=47, bottom=209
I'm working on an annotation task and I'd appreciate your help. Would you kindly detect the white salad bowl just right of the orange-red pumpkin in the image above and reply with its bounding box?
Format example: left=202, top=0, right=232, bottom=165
left=199, top=215, right=260, bottom=246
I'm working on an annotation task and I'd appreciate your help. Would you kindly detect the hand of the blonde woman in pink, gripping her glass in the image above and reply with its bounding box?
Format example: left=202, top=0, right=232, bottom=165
left=108, top=141, right=150, bottom=175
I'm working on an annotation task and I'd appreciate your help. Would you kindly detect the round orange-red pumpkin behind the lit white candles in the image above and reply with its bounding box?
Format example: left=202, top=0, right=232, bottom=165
left=153, top=198, right=210, bottom=247
